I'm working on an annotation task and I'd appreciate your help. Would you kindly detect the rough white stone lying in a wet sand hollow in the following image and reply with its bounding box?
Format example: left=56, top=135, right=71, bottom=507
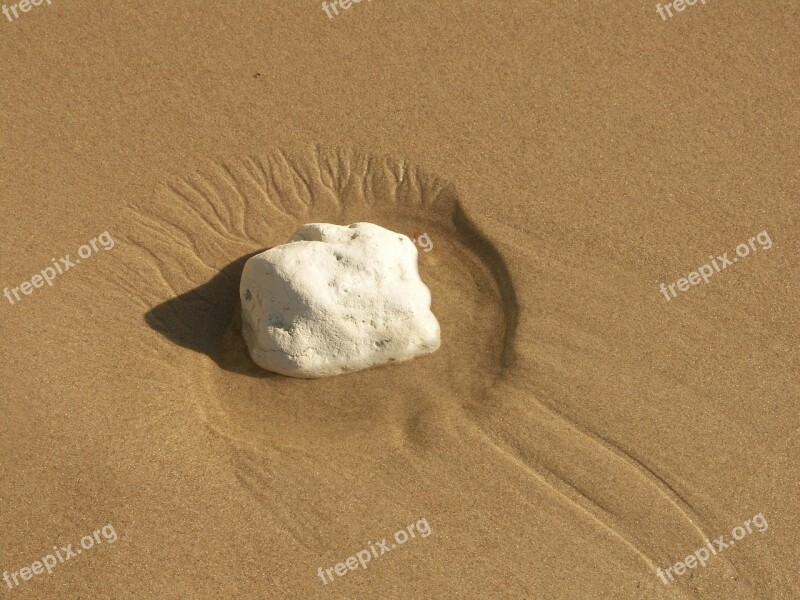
left=239, top=223, right=440, bottom=377
